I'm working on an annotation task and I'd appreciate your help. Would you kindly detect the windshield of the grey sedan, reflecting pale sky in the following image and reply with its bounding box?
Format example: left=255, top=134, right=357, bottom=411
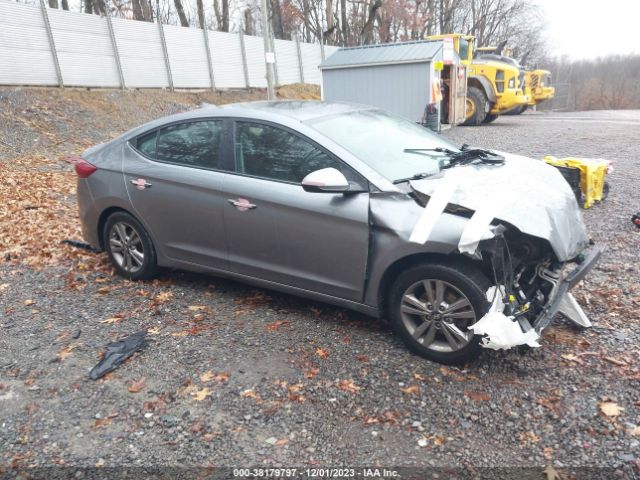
left=309, top=110, right=459, bottom=182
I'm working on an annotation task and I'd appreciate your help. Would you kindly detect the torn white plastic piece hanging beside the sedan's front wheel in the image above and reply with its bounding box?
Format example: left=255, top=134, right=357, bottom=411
left=469, top=286, right=540, bottom=350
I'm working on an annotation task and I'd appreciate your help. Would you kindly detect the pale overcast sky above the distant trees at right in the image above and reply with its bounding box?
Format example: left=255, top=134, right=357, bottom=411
left=532, top=0, right=640, bottom=59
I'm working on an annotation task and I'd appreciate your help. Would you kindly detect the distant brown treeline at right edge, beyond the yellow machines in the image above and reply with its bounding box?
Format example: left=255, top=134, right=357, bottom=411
left=546, top=54, right=640, bottom=110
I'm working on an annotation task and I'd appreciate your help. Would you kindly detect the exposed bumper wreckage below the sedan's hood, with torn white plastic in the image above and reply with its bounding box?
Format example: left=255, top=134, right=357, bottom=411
left=470, top=224, right=602, bottom=350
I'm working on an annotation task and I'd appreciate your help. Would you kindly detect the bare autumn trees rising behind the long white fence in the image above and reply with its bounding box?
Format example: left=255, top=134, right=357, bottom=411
left=33, top=0, right=545, bottom=63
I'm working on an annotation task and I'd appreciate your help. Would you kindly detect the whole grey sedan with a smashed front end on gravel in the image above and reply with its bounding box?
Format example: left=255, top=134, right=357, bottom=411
left=75, top=102, right=599, bottom=363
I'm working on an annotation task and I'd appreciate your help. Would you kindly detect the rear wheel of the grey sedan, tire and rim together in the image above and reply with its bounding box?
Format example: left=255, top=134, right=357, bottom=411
left=102, top=212, right=157, bottom=280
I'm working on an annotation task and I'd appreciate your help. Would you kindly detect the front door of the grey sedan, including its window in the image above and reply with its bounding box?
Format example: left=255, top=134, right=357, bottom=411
left=223, top=120, right=369, bottom=301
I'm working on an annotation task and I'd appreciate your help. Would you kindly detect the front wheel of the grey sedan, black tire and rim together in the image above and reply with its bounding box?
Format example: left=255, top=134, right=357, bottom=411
left=388, top=263, right=491, bottom=365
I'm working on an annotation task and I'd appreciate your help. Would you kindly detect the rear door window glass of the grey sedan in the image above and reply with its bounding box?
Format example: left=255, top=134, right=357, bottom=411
left=141, top=120, right=222, bottom=169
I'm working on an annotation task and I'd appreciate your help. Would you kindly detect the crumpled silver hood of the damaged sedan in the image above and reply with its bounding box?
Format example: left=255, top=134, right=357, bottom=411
left=411, top=152, right=589, bottom=261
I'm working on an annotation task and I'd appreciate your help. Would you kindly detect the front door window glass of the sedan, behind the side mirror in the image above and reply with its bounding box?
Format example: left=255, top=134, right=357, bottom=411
left=235, top=122, right=340, bottom=183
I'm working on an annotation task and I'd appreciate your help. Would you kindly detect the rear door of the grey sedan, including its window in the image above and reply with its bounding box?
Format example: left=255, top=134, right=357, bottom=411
left=123, top=119, right=228, bottom=269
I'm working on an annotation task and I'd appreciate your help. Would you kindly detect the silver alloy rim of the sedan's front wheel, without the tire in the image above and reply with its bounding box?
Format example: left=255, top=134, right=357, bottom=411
left=400, top=279, right=476, bottom=353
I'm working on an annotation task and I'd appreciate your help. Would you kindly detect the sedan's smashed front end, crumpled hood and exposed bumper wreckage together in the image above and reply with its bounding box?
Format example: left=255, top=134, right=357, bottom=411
left=400, top=155, right=602, bottom=350
